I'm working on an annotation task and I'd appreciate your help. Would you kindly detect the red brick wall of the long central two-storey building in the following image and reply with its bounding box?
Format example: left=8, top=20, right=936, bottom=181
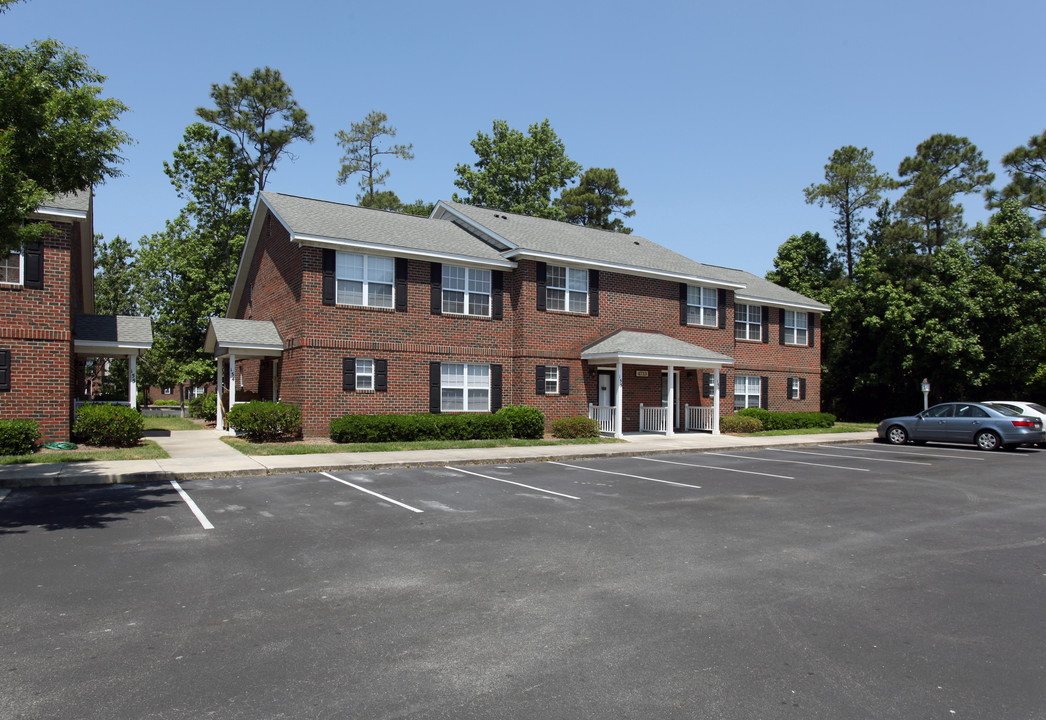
left=237, top=207, right=820, bottom=435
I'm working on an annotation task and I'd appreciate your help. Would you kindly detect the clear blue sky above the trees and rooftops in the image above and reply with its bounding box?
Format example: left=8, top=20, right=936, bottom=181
left=0, top=0, right=1046, bottom=275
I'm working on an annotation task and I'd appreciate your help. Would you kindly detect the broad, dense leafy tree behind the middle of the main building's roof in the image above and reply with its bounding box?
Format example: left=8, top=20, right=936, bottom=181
left=453, top=118, right=582, bottom=220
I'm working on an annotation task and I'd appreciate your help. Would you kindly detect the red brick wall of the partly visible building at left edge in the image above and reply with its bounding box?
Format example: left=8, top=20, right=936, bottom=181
left=0, top=223, right=79, bottom=443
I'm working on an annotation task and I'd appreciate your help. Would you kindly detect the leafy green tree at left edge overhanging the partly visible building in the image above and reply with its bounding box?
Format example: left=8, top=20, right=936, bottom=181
left=0, top=40, right=131, bottom=253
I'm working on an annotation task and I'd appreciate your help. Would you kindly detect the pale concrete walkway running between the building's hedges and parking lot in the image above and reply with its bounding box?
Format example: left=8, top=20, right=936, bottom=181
left=0, top=430, right=876, bottom=488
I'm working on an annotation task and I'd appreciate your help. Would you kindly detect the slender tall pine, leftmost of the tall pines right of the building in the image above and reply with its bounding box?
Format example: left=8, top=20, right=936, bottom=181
left=803, top=145, right=893, bottom=277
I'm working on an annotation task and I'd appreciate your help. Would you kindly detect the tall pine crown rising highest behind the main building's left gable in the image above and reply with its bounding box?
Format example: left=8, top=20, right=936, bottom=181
left=197, top=67, right=313, bottom=193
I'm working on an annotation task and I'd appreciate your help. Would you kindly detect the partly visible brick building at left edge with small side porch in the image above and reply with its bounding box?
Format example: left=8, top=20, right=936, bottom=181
left=0, top=192, right=153, bottom=442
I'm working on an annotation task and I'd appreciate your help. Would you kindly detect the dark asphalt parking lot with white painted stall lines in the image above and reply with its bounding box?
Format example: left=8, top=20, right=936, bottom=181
left=0, top=444, right=1046, bottom=719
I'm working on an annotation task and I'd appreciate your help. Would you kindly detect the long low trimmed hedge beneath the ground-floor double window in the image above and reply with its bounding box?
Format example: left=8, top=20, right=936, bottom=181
left=331, top=413, right=513, bottom=443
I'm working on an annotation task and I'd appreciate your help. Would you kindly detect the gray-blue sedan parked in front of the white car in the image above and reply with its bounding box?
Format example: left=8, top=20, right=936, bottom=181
left=879, top=403, right=1044, bottom=450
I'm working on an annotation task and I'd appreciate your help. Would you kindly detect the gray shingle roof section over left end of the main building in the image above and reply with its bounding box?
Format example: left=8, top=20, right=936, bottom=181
left=262, top=193, right=504, bottom=264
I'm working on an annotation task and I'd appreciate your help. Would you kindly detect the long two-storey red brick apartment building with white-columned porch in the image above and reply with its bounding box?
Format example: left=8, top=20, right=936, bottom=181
left=212, top=193, right=828, bottom=436
